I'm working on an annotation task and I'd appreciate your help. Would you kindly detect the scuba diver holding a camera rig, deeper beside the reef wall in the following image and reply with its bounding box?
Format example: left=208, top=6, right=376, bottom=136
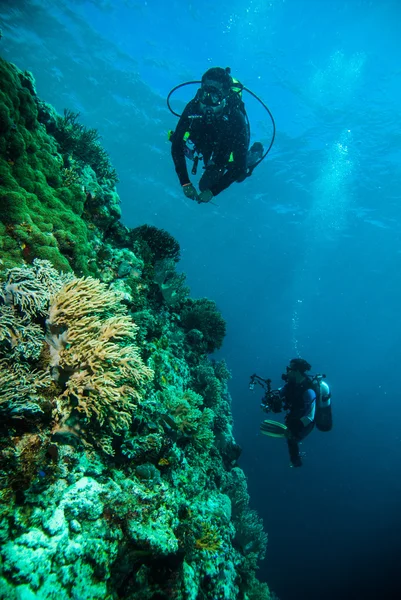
left=249, top=358, right=333, bottom=467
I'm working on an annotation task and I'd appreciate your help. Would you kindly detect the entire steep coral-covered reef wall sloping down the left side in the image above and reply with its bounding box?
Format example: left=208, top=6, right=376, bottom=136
left=0, top=60, right=272, bottom=600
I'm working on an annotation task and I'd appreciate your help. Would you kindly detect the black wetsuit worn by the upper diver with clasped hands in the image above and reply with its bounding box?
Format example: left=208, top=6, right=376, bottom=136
left=171, top=99, right=249, bottom=196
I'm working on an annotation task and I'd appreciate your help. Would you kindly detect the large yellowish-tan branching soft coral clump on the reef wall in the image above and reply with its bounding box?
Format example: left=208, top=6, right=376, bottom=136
left=46, top=277, right=153, bottom=446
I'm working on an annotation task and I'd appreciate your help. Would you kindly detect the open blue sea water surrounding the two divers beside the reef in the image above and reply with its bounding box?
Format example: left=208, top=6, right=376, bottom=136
left=0, top=0, right=401, bottom=600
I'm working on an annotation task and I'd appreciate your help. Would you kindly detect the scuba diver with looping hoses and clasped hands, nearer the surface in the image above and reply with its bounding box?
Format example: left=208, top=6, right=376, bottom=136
left=167, top=67, right=275, bottom=203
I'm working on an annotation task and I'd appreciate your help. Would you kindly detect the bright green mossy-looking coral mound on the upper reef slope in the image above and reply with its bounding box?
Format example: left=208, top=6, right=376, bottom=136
left=0, top=59, right=119, bottom=275
